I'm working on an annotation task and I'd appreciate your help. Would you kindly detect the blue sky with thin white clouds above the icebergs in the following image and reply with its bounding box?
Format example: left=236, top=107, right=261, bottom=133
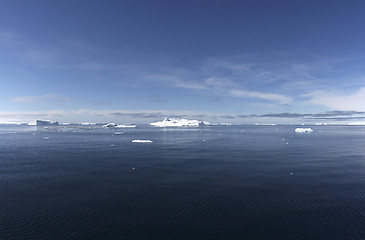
left=0, top=0, right=365, bottom=124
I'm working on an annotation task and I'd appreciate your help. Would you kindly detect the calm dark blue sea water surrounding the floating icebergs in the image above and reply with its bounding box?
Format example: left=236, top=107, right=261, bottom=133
left=0, top=126, right=365, bottom=240
